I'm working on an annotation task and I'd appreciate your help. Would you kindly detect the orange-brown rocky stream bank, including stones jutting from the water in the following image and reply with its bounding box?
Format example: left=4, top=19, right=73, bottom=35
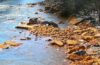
left=0, top=2, right=100, bottom=65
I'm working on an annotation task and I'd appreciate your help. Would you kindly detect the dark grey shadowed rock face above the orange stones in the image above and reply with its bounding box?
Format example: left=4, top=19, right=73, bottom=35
left=45, top=0, right=100, bottom=24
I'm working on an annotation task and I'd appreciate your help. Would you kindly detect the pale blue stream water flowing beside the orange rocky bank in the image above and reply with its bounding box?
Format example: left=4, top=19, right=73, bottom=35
left=0, top=0, right=66, bottom=65
